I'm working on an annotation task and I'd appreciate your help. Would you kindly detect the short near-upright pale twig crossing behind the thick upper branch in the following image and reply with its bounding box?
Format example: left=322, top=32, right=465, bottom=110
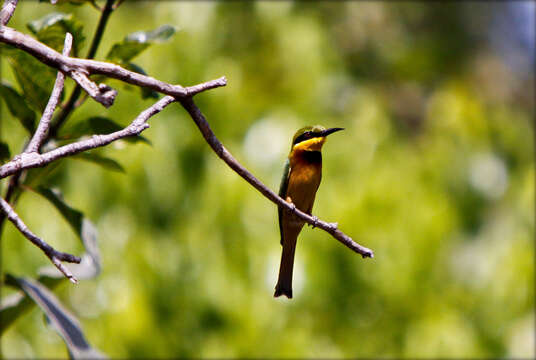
left=24, top=33, right=73, bottom=153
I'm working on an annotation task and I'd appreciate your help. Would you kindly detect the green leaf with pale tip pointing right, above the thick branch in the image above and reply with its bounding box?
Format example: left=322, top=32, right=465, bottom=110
left=106, top=25, right=176, bottom=63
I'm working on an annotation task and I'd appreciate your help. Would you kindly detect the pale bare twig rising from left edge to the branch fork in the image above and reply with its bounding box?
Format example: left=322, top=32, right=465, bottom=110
left=0, top=96, right=182, bottom=179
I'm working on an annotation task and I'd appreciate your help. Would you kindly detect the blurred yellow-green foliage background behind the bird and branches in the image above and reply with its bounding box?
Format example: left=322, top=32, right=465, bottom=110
left=1, top=1, right=535, bottom=358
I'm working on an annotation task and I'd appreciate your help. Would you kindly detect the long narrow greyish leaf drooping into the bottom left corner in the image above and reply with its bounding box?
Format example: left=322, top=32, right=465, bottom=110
left=5, top=274, right=105, bottom=359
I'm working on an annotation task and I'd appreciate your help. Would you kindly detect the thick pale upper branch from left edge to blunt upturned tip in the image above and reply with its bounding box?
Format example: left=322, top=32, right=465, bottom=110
left=0, top=26, right=226, bottom=105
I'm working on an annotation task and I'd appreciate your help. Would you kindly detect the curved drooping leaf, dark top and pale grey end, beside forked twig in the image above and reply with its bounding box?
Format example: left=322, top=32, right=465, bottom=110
left=35, top=186, right=101, bottom=279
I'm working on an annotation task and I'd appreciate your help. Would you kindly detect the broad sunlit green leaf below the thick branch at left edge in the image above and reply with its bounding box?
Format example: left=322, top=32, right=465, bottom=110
left=1, top=46, right=56, bottom=113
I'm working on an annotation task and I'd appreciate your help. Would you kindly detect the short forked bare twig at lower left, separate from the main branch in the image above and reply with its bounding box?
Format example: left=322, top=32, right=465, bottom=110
left=0, top=198, right=81, bottom=283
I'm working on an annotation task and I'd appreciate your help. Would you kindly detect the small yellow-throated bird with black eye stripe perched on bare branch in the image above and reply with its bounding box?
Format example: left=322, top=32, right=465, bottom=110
left=274, top=125, right=344, bottom=299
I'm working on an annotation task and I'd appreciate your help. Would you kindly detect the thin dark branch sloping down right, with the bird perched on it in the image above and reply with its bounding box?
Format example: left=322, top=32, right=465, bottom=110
left=179, top=97, right=374, bottom=258
